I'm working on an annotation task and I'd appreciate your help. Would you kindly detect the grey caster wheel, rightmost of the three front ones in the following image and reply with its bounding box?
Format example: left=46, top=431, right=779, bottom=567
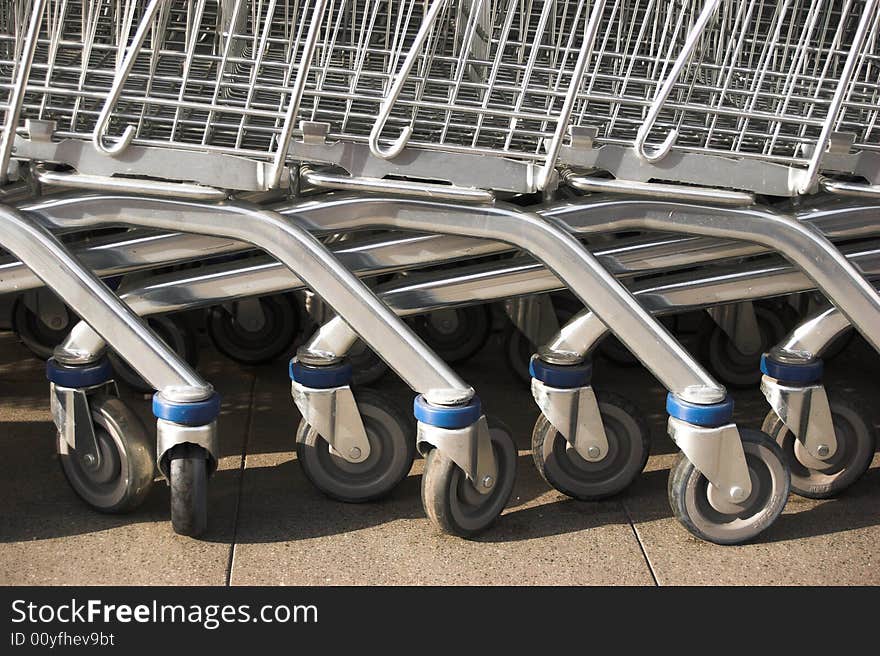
left=667, top=429, right=791, bottom=544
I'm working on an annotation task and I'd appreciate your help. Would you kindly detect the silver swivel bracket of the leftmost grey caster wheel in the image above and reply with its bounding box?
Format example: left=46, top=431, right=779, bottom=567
left=49, top=381, right=119, bottom=467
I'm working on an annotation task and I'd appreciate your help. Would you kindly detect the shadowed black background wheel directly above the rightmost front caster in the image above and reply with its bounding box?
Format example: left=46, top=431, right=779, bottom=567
left=699, top=305, right=787, bottom=389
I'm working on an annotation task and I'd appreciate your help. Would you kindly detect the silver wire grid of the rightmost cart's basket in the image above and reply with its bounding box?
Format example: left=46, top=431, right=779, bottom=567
left=573, top=0, right=880, bottom=165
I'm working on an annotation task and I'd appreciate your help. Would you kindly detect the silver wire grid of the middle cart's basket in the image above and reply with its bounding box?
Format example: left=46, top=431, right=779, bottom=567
left=301, top=0, right=589, bottom=160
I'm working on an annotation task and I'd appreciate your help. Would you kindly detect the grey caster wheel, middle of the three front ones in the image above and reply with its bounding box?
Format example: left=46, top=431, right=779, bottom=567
left=422, top=418, right=517, bottom=538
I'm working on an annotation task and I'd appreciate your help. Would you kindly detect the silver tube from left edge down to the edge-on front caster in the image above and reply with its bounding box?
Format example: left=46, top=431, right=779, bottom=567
left=0, top=205, right=213, bottom=402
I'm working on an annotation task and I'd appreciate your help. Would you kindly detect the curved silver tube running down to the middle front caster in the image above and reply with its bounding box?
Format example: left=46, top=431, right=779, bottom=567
left=20, top=196, right=473, bottom=401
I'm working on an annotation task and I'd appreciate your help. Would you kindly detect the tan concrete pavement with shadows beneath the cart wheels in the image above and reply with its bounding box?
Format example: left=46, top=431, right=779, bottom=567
left=0, top=335, right=880, bottom=585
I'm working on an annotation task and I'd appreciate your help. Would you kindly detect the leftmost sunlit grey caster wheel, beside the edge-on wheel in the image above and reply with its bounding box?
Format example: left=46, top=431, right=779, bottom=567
left=56, top=396, right=156, bottom=513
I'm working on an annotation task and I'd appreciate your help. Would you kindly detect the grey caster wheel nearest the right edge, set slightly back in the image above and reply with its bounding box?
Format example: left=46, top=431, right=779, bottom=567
left=761, top=398, right=876, bottom=499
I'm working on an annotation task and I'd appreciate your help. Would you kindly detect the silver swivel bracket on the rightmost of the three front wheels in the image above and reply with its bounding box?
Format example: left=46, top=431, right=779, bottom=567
left=667, top=417, right=752, bottom=505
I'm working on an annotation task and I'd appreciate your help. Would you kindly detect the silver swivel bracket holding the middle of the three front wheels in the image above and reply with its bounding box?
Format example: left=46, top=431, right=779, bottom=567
left=416, top=415, right=498, bottom=494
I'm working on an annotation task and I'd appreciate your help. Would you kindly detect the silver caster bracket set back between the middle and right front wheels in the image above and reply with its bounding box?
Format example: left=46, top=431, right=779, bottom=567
left=532, top=378, right=608, bottom=462
